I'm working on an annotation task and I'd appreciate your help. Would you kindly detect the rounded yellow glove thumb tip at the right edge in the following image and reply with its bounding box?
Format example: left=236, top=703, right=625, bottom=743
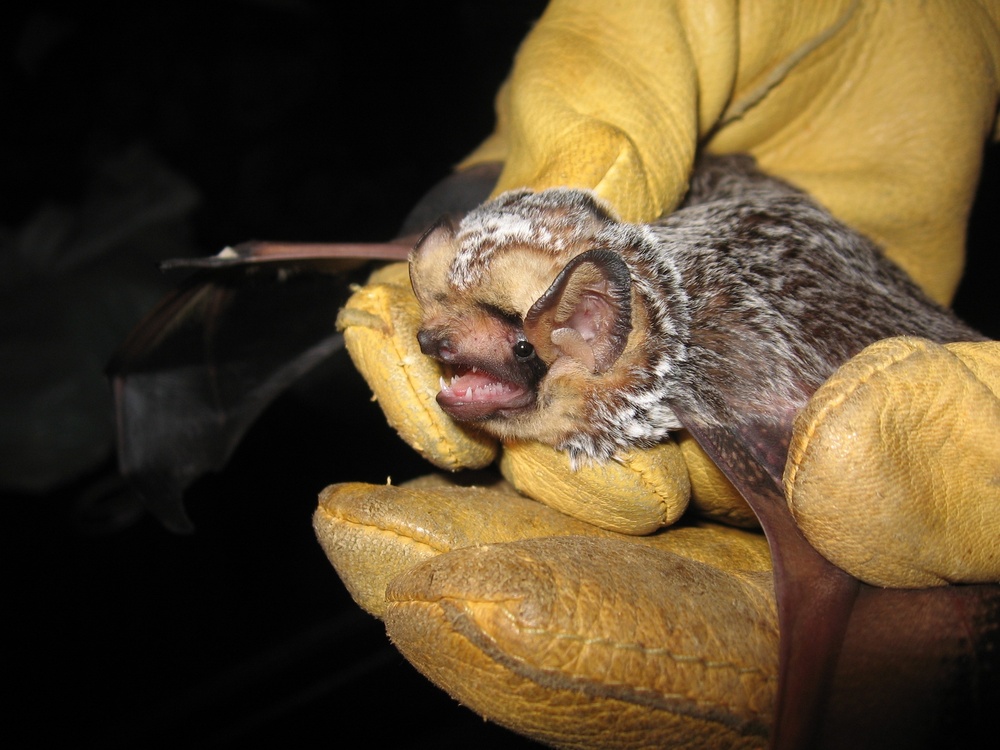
left=785, top=337, right=1000, bottom=588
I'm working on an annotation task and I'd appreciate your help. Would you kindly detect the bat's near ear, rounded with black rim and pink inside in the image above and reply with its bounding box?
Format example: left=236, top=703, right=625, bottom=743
left=524, top=250, right=632, bottom=373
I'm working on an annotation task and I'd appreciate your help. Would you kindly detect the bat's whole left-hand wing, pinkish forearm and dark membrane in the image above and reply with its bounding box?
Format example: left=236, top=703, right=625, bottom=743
left=106, top=164, right=499, bottom=533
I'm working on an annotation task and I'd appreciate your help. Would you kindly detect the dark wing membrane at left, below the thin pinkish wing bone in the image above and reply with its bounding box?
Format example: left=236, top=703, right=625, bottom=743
left=108, top=264, right=378, bottom=531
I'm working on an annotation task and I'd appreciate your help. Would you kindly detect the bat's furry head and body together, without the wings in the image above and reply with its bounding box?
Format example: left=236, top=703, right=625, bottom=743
left=410, top=156, right=982, bottom=459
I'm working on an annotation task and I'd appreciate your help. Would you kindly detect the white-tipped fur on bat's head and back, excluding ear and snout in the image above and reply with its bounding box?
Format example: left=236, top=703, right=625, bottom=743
left=414, top=157, right=981, bottom=460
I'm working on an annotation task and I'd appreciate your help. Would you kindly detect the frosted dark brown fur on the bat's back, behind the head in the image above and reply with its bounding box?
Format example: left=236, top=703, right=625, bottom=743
left=635, top=157, right=982, bottom=428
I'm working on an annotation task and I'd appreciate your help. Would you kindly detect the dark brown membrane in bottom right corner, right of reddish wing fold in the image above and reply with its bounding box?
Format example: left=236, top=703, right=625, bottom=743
left=822, top=583, right=1000, bottom=750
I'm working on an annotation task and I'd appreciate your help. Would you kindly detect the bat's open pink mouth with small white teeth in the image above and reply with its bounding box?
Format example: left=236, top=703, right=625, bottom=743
left=437, top=364, right=535, bottom=421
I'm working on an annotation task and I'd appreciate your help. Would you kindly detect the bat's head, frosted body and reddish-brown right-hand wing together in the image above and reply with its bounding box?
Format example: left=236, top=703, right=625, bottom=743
left=410, top=156, right=1000, bottom=748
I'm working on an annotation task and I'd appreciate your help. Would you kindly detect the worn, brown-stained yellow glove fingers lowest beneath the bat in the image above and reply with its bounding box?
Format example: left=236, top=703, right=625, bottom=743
left=314, top=477, right=777, bottom=747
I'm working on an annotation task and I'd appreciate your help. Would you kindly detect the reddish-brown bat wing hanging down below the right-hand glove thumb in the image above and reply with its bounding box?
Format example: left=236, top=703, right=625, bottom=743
left=678, top=410, right=1000, bottom=749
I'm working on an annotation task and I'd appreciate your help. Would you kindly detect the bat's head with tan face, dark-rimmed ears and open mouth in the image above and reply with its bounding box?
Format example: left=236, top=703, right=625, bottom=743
left=410, top=189, right=684, bottom=456
